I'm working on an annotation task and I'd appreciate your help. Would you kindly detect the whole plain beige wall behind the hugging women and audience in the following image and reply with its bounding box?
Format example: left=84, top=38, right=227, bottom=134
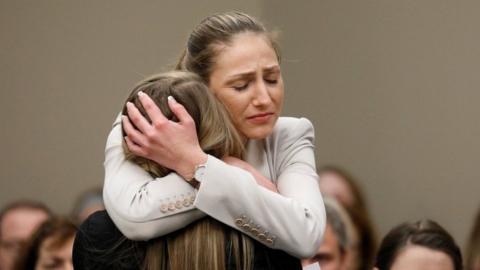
left=0, top=0, right=480, bottom=249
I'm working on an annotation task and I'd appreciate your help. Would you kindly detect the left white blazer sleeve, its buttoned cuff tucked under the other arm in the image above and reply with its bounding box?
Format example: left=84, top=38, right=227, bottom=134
left=103, top=117, right=205, bottom=240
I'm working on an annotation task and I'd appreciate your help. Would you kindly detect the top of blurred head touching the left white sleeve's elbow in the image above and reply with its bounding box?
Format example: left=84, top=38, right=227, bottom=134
left=70, top=187, right=105, bottom=224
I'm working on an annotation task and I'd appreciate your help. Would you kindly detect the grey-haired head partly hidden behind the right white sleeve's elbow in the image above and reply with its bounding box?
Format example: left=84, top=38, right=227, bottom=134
left=302, top=197, right=353, bottom=270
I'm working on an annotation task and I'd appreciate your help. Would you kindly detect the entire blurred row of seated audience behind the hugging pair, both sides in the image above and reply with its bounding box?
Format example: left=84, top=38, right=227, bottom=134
left=0, top=166, right=480, bottom=270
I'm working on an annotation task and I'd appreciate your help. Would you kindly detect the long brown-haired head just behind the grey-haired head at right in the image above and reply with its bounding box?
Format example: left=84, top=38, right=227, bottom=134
left=318, top=166, right=377, bottom=270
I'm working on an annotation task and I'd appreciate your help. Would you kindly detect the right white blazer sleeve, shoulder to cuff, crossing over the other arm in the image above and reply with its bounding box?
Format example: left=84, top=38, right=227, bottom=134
left=194, top=118, right=326, bottom=258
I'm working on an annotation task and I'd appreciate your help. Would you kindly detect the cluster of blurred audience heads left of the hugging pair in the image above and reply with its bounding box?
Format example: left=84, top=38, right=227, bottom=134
left=0, top=188, right=104, bottom=270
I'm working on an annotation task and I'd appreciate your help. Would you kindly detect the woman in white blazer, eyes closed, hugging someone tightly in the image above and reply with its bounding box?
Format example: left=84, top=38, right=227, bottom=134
left=104, top=12, right=325, bottom=258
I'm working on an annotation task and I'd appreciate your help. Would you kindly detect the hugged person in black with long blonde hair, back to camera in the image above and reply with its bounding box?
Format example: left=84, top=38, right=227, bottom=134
left=74, top=71, right=301, bottom=270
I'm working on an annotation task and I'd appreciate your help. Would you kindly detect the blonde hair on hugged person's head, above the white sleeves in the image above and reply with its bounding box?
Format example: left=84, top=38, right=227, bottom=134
left=122, top=71, right=244, bottom=177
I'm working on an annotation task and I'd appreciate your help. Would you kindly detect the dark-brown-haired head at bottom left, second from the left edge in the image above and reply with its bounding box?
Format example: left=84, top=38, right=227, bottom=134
left=14, top=217, right=77, bottom=270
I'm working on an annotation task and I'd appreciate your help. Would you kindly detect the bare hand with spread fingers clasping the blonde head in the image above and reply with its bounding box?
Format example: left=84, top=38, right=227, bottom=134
left=122, top=92, right=207, bottom=179
